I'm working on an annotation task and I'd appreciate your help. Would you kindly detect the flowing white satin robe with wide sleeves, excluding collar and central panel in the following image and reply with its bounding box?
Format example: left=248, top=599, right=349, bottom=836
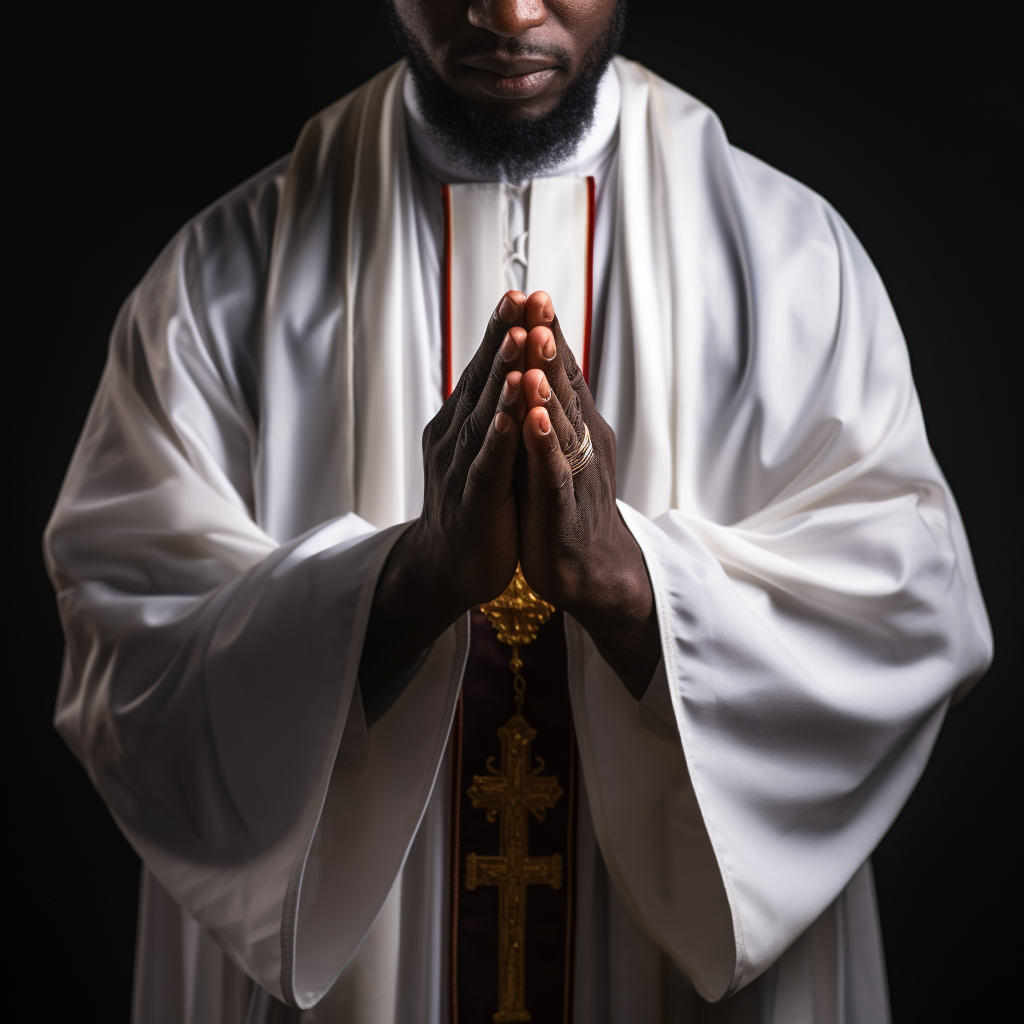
left=46, top=58, right=990, bottom=1024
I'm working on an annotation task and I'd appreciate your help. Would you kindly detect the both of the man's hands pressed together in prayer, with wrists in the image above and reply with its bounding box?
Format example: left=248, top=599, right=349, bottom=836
left=359, top=291, right=660, bottom=697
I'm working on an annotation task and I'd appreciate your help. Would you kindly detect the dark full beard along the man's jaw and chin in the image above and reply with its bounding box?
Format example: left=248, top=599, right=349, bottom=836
left=388, top=0, right=626, bottom=181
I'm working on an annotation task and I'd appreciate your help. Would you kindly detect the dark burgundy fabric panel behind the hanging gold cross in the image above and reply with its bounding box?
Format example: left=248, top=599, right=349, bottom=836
left=450, top=611, right=579, bottom=1024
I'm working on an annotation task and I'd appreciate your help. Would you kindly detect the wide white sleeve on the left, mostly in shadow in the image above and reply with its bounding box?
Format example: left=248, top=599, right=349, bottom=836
left=45, top=190, right=466, bottom=1006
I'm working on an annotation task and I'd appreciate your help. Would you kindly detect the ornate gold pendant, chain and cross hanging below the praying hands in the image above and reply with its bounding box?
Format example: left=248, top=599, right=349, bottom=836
left=466, top=565, right=562, bottom=1022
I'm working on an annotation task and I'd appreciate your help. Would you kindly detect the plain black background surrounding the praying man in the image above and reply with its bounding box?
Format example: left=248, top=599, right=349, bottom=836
left=12, top=0, right=1021, bottom=1024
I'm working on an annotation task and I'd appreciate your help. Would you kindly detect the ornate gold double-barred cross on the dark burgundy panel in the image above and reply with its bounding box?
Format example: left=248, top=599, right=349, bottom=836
left=466, top=714, right=562, bottom=1022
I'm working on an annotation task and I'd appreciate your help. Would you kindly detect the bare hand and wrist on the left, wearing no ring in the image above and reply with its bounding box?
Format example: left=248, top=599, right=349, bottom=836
left=359, top=291, right=526, bottom=695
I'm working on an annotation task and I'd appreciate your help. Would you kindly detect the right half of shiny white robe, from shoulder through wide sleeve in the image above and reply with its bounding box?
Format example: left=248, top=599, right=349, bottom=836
left=569, top=60, right=991, bottom=999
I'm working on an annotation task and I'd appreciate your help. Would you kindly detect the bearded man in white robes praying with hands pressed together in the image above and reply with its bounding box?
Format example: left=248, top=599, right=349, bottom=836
left=45, top=0, right=991, bottom=1024
